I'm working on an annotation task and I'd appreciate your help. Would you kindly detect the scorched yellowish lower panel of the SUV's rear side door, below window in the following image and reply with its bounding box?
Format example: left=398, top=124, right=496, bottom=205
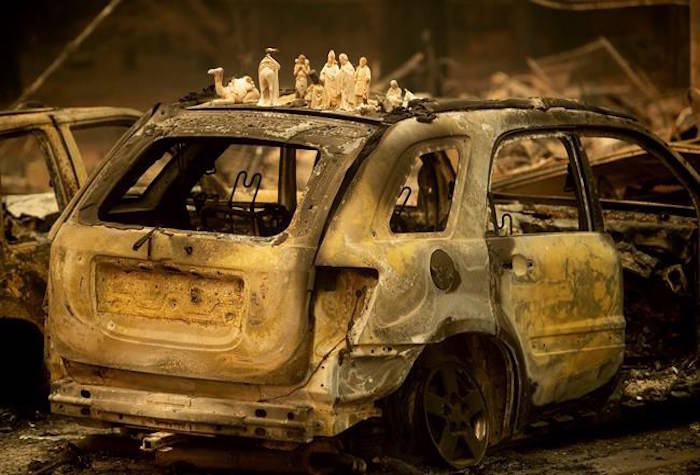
left=488, top=232, right=625, bottom=406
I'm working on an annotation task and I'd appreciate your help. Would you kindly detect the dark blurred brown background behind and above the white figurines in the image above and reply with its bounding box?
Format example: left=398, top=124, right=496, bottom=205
left=0, top=0, right=689, bottom=109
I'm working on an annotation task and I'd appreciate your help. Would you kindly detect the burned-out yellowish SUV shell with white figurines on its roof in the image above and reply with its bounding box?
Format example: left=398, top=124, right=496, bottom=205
left=47, top=99, right=700, bottom=467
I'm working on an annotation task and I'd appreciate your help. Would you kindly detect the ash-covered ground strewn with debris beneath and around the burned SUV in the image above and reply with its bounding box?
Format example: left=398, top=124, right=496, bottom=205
left=0, top=361, right=700, bottom=475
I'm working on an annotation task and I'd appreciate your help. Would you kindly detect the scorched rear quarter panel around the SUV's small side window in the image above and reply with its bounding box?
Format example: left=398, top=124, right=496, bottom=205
left=317, top=115, right=495, bottom=345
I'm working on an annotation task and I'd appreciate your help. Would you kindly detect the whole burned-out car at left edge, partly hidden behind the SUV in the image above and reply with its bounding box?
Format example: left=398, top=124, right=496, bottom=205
left=0, top=107, right=140, bottom=406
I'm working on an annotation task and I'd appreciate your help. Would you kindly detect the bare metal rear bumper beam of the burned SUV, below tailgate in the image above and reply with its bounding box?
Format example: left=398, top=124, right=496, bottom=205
left=49, top=379, right=320, bottom=442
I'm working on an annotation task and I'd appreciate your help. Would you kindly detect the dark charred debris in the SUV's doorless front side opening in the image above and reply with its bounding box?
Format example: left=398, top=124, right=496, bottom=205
left=605, top=210, right=697, bottom=361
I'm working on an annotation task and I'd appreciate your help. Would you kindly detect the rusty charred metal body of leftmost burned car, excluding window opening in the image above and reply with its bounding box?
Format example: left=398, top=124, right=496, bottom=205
left=0, top=107, right=141, bottom=332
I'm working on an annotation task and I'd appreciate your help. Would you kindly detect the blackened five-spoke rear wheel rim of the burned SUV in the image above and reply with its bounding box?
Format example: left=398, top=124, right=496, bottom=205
left=423, top=364, right=488, bottom=468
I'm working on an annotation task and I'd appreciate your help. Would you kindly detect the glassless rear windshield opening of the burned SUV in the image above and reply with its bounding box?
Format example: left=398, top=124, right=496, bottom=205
left=99, top=137, right=319, bottom=236
